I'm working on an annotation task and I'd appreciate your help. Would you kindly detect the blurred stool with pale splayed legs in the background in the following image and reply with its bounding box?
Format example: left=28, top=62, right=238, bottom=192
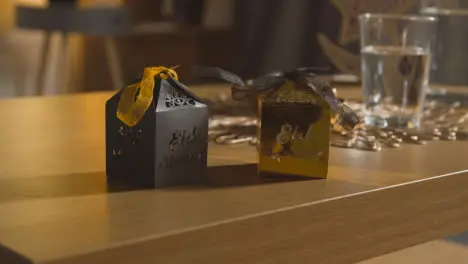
left=16, top=1, right=131, bottom=95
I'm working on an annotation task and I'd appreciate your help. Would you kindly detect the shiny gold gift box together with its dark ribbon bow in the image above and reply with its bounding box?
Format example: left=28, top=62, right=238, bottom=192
left=198, top=67, right=359, bottom=178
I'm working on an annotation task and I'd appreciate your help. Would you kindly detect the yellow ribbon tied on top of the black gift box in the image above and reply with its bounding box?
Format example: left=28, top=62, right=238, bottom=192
left=117, top=67, right=179, bottom=127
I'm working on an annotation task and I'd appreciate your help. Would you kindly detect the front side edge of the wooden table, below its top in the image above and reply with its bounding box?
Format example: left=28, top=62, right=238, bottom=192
left=23, top=171, right=468, bottom=264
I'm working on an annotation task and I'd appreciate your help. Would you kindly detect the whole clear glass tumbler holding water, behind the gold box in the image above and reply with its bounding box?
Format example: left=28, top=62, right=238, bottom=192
left=359, top=14, right=437, bottom=127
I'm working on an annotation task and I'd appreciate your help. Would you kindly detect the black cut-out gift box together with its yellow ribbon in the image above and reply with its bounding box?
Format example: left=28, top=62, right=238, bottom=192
left=106, top=67, right=208, bottom=188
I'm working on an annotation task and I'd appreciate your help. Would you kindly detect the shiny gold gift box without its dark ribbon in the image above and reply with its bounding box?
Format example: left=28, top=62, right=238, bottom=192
left=257, top=80, right=331, bottom=178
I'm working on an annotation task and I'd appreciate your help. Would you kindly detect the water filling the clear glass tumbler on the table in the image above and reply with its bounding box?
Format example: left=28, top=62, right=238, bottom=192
left=361, top=45, right=431, bottom=127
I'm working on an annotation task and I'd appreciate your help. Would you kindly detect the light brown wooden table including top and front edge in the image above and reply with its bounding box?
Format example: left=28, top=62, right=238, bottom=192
left=0, top=85, right=468, bottom=264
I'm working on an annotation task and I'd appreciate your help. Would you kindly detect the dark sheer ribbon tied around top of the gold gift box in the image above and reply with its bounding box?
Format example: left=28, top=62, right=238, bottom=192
left=195, top=67, right=360, bottom=130
